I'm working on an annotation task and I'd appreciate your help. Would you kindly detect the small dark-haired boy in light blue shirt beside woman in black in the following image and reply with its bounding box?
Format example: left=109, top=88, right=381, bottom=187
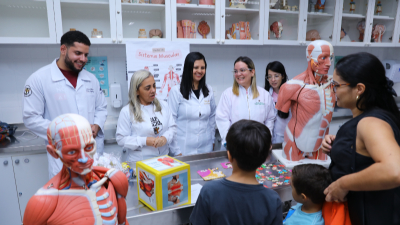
left=283, top=164, right=332, bottom=225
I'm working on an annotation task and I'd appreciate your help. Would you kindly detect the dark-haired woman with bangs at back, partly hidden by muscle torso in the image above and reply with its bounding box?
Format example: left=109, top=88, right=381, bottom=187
left=265, top=61, right=292, bottom=144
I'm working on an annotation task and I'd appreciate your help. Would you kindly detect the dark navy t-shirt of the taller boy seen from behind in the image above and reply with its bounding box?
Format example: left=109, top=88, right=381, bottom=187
left=190, top=178, right=282, bottom=225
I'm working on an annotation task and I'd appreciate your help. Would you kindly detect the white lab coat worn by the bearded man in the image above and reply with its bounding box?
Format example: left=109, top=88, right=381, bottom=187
left=23, top=59, right=107, bottom=178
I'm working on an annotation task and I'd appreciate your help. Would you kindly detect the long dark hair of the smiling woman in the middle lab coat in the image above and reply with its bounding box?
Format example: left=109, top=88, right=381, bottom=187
left=180, top=52, right=209, bottom=100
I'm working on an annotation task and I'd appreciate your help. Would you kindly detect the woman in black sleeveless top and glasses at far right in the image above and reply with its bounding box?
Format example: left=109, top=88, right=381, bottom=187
left=322, top=53, right=400, bottom=225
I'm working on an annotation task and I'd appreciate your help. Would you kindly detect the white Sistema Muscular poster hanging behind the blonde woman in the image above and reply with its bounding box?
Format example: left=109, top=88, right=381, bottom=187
left=126, top=41, right=189, bottom=101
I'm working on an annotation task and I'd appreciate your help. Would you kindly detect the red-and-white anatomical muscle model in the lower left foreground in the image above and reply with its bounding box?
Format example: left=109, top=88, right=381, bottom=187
left=23, top=114, right=128, bottom=225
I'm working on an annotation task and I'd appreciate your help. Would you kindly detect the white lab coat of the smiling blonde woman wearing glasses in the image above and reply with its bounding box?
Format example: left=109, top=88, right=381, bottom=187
left=215, top=85, right=276, bottom=149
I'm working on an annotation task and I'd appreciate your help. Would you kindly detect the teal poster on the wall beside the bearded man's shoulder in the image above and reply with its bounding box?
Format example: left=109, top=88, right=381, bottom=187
left=84, top=56, right=109, bottom=97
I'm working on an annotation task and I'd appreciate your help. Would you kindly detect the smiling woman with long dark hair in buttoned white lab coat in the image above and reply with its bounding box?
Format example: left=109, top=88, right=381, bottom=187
left=168, top=52, right=216, bottom=155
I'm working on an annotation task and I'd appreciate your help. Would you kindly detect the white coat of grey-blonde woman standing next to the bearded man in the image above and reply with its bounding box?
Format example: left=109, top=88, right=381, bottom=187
left=116, top=101, right=180, bottom=162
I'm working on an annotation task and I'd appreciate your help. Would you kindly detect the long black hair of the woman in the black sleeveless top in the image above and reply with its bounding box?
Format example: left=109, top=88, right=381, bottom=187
left=336, top=52, right=400, bottom=128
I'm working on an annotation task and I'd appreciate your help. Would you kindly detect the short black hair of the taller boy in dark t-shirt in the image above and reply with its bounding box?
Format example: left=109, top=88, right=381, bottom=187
left=226, top=120, right=271, bottom=171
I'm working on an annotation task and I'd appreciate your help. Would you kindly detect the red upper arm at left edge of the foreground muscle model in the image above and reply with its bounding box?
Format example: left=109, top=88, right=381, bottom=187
left=23, top=195, right=58, bottom=225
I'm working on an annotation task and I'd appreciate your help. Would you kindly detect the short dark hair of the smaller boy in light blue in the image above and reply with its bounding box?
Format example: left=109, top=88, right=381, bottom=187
left=292, top=164, right=332, bottom=204
